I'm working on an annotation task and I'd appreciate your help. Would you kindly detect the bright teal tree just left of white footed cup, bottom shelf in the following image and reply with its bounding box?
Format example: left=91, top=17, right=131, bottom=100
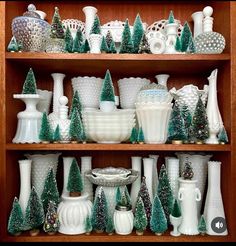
left=150, top=195, right=168, bottom=235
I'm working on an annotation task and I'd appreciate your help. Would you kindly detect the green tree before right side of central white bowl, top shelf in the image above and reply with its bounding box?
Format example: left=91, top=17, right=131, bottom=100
left=120, top=19, right=134, bottom=54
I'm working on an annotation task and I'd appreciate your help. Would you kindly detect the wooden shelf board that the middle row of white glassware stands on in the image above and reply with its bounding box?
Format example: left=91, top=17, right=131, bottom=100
left=6, top=143, right=231, bottom=151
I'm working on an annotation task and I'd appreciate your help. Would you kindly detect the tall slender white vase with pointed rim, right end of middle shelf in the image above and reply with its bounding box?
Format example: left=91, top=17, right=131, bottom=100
left=205, top=69, right=223, bottom=144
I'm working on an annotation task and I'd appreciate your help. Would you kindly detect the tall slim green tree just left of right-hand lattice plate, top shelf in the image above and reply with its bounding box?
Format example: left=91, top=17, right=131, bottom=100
left=132, top=14, right=144, bottom=53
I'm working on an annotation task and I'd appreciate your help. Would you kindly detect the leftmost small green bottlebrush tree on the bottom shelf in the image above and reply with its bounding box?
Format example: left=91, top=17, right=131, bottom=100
left=7, top=197, right=24, bottom=235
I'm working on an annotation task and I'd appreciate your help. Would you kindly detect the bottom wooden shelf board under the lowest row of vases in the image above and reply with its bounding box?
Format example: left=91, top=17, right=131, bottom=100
left=4, top=231, right=230, bottom=242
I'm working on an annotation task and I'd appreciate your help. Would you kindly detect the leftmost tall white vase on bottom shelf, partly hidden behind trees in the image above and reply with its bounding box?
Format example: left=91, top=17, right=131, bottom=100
left=18, top=160, right=32, bottom=216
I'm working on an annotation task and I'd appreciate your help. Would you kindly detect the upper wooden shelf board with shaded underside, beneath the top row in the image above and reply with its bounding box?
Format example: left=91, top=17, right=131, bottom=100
left=5, top=52, right=231, bottom=77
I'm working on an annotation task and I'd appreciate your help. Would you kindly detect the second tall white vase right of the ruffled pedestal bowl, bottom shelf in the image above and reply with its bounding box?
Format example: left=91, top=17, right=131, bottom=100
left=143, top=158, right=154, bottom=203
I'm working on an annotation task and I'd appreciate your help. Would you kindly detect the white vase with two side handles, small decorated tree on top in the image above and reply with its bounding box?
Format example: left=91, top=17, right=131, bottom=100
left=178, top=178, right=201, bottom=235
